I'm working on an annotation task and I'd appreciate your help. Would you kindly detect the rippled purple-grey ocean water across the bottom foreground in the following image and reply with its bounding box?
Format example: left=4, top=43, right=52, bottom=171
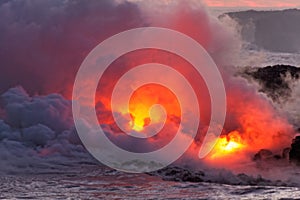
left=0, top=166, right=300, bottom=199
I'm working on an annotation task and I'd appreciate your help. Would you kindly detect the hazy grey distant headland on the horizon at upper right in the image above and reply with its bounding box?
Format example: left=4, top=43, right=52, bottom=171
left=219, top=9, right=300, bottom=53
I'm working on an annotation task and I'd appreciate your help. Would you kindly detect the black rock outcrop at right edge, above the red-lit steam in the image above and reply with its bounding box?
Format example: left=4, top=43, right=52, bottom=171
left=245, top=65, right=300, bottom=101
